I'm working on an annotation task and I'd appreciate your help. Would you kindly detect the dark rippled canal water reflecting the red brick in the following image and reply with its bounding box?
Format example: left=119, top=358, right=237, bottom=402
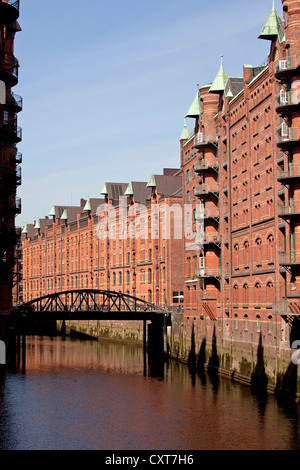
left=0, top=336, right=300, bottom=451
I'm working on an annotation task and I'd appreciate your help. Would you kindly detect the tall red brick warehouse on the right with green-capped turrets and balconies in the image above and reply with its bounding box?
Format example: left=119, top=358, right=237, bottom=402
left=180, top=0, right=300, bottom=347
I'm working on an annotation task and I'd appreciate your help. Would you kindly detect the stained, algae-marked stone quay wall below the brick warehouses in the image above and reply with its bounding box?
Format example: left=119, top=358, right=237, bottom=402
left=57, top=315, right=300, bottom=400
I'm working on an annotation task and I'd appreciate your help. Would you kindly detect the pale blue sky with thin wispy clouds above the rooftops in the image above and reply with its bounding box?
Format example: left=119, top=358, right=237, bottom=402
left=14, top=0, right=282, bottom=226
